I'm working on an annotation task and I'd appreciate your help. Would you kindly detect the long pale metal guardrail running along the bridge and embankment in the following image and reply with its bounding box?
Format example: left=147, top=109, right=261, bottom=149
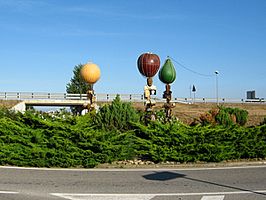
left=0, top=92, right=265, bottom=103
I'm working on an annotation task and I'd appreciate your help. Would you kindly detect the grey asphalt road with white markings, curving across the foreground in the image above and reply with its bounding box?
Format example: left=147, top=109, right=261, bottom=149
left=0, top=165, right=266, bottom=200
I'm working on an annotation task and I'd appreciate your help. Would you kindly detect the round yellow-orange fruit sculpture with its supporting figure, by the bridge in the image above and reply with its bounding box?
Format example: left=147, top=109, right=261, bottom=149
left=80, top=63, right=101, bottom=111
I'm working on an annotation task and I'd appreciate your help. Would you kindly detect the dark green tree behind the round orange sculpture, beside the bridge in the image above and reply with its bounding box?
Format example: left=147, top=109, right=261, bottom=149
left=66, top=64, right=91, bottom=114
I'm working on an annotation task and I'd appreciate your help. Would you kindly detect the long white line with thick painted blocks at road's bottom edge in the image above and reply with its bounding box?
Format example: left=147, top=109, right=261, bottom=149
left=50, top=190, right=266, bottom=200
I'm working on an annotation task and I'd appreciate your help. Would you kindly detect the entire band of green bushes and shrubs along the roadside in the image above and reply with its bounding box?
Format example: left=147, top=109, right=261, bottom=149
left=0, top=97, right=266, bottom=168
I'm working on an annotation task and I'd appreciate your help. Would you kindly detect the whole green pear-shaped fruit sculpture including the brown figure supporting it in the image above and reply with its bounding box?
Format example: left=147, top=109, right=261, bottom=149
left=159, top=58, right=176, bottom=120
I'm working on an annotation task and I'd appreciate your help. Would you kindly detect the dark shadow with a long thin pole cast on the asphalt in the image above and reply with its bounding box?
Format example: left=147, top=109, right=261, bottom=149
left=143, top=171, right=266, bottom=196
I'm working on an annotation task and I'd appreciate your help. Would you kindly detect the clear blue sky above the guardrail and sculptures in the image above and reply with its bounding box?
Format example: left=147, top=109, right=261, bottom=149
left=0, top=0, right=266, bottom=98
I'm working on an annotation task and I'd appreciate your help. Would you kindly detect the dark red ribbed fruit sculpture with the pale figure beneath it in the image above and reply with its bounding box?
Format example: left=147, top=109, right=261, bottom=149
left=137, top=53, right=160, bottom=120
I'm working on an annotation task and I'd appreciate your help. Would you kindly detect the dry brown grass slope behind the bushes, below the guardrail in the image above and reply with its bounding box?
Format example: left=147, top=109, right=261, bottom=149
left=134, top=103, right=266, bottom=126
